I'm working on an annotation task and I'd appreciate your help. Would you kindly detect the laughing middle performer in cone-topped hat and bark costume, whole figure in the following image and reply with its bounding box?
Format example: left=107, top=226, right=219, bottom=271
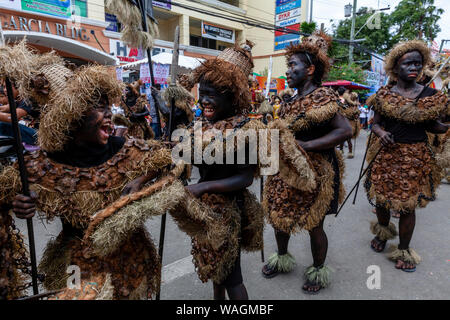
left=172, top=42, right=265, bottom=300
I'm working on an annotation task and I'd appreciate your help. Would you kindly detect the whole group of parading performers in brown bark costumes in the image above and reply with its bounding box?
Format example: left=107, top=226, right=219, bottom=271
left=0, top=33, right=450, bottom=300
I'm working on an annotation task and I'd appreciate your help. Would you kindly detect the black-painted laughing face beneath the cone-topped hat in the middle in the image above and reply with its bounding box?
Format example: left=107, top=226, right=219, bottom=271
left=198, top=81, right=233, bottom=121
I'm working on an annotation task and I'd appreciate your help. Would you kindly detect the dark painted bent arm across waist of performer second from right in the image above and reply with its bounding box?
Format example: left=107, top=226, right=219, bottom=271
left=297, top=113, right=353, bottom=151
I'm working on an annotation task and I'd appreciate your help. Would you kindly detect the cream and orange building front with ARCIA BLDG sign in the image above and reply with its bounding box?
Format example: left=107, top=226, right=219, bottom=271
left=0, top=0, right=309, bottom=77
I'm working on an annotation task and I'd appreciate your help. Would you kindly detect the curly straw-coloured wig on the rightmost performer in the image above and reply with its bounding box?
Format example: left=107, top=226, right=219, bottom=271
left=384, top=40, right=432, bottom=81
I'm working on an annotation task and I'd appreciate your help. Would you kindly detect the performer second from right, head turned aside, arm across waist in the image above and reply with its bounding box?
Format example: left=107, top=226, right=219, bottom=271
left=262, top=33, right=352, bottom=293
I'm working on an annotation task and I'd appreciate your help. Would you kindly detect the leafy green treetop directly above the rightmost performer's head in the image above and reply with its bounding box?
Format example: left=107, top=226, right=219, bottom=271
left=391, top=0, right=444, bottom=42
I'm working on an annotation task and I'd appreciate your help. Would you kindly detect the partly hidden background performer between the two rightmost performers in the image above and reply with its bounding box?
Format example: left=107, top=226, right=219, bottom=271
left=338, top=87, right=360, bottom=159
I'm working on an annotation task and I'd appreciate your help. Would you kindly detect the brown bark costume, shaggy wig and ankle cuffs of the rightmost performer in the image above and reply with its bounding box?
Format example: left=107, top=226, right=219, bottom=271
left=364, top=41, right=447, bottom=272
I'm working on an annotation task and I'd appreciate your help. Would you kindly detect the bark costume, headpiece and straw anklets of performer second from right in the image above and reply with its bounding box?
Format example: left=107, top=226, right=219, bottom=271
left=263, top=34, right=345, bottom=288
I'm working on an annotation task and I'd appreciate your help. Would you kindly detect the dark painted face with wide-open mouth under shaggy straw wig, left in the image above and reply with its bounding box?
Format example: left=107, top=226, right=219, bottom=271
left=74, top=95, right=112, bottom=146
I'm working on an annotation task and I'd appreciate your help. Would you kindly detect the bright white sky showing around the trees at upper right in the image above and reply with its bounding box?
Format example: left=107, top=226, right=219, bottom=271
left=313, top=0, right=450, bottom=49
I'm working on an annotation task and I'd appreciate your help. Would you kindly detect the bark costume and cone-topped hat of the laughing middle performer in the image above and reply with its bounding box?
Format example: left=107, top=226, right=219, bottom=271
left=172, top=43, right=265, bottom=298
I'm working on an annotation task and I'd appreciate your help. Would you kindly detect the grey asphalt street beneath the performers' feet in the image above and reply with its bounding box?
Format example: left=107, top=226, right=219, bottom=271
left=17, top=131, right=450, bottom=300
